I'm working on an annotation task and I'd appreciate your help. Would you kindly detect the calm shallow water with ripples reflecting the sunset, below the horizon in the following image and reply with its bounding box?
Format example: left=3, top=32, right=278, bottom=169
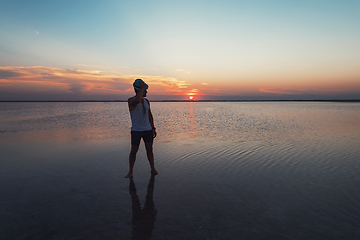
left=0, top=102, right=360, bottom=239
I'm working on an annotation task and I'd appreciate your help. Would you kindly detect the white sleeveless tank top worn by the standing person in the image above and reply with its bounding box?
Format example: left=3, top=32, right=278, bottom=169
left=130, top=98, right=152, bottom=131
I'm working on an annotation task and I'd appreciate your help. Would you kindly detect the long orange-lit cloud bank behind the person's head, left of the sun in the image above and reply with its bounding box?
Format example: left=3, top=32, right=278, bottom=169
left=0, top=66, right=188, bottom=100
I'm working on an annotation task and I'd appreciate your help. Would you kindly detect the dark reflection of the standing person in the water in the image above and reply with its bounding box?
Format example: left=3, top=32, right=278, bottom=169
left=129, top=174, right=157, bottom=240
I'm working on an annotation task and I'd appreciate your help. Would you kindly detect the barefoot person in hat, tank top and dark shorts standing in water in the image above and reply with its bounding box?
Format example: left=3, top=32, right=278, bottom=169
left=125, top=79, right=159, bottom=178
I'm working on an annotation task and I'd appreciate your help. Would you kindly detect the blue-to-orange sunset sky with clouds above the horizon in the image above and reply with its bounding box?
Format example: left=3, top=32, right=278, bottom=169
left=0, top=0, right=360, bottom=100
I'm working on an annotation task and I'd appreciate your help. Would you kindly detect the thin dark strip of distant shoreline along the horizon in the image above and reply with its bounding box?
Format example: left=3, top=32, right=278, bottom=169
left=0, top=99, right=360, bottom=102
